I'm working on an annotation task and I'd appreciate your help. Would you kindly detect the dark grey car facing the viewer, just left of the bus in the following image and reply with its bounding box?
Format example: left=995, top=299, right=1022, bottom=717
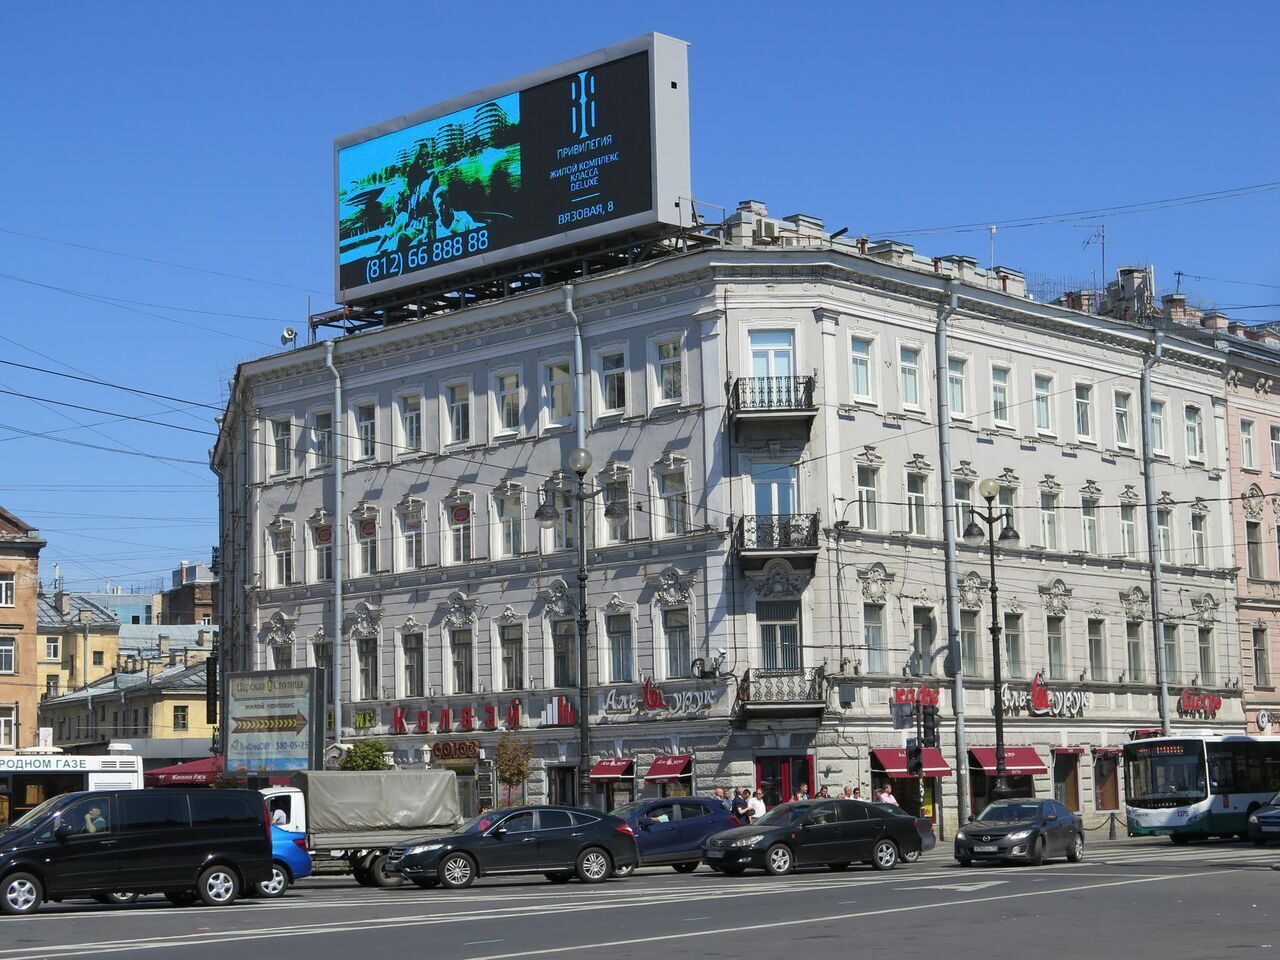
left=955, top=797, right=1084, bottom=867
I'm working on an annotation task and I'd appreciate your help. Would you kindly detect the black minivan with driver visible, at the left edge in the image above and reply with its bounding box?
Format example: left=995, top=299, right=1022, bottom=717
left=0, top=788, right=271, bottom=915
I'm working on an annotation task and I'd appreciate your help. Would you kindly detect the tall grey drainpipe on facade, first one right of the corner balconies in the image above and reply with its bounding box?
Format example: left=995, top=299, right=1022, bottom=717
left=933, top=276, right=962, bottom=833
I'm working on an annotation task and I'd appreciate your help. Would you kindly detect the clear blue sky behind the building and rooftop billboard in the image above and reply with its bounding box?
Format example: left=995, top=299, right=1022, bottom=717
left=0, top=0, right=1280, bottom=589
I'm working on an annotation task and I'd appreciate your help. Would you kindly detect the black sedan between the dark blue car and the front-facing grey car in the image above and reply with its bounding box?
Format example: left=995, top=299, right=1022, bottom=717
left=703, top=800, right=920, bottom=877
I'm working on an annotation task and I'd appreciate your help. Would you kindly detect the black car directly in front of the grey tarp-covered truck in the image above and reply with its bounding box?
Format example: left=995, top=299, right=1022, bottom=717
left=387, top=806, right=639, bottom=890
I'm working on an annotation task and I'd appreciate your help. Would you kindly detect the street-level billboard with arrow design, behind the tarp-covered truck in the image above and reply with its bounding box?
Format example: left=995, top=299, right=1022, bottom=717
left=224, top=669, right=324, bottom=773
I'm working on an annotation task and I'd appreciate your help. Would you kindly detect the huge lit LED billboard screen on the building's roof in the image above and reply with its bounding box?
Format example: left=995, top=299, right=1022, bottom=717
left=335, top=35, right=691, bottom=303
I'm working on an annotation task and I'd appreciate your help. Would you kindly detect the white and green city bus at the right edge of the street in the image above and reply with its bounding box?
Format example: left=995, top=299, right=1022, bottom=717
left=1124, top=736, right=1280, bottom=844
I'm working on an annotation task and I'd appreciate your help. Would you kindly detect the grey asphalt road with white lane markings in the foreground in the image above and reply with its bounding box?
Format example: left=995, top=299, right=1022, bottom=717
left=0, top=841, right=1280, bottom=960
